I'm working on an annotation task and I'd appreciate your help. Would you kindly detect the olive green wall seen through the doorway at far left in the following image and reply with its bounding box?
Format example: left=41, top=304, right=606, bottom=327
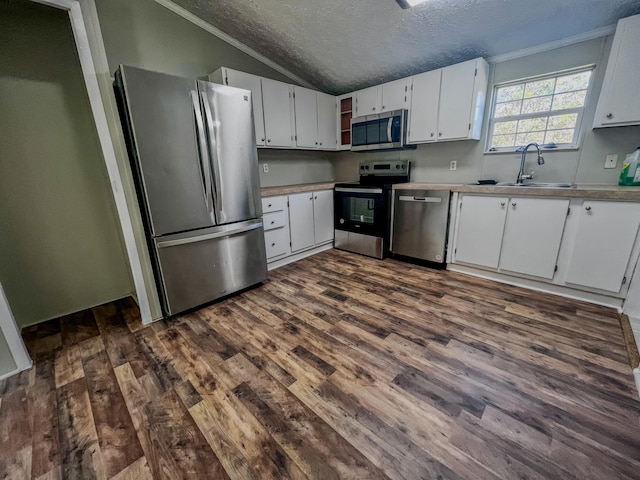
left=0, top=0, right=133, bottom=326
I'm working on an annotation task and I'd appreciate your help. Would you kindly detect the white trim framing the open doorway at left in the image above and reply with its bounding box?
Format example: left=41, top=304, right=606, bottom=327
left=0, top=0, right=152, bottom=373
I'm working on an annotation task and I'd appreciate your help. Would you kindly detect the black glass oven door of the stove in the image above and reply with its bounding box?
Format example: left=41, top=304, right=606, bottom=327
left=334, top=187, right=389, bottom=238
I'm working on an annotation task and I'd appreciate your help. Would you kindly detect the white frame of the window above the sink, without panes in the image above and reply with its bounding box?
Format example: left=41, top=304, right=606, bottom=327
left=484, top=64, right=596, bottom=154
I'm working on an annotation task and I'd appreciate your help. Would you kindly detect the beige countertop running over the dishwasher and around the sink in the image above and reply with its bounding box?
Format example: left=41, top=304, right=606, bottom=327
left=393, top=182, right=640, bottom=202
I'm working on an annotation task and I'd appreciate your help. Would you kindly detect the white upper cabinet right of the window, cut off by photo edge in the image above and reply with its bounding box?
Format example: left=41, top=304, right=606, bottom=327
left=593, top=15, right=640, bottom=128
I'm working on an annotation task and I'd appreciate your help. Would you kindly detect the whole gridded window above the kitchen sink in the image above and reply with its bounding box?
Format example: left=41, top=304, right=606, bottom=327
left=487, top=67, right=593, bottom=152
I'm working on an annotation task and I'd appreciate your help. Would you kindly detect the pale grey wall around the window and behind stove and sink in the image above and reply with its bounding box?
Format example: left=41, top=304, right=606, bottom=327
left=335, top=36, right=640, bottom=185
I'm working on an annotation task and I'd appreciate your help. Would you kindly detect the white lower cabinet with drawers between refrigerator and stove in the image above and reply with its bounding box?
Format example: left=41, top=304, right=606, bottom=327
left=262, top=190, right=334, bottom=262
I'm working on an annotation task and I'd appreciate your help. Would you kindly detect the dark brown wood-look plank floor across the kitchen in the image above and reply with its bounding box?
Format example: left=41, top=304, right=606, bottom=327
left=0, top=250, right=640, bottom=480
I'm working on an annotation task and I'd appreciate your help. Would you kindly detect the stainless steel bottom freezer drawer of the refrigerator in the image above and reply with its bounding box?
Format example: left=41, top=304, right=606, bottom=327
left=155, top=220, right=267, bottom=315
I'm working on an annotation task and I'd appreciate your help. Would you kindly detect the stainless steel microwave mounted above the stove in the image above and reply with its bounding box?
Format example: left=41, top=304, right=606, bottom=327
left=351, top=109, right=415, bottom=152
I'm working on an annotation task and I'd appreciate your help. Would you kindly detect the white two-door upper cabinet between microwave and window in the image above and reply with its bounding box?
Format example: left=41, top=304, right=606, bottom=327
left=409, top=58, right=489, bottom=143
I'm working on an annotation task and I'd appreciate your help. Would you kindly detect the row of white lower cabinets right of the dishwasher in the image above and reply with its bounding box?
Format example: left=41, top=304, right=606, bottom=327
left=452, top=195, right=640, bottom=298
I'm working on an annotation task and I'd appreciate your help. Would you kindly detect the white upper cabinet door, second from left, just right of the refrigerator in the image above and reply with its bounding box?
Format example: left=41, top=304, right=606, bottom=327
left=261, top=78, right=293, bottom=147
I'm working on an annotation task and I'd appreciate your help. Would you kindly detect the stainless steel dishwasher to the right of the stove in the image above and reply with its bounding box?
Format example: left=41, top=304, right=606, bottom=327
left=391, top=190, right=451, bottom=263
